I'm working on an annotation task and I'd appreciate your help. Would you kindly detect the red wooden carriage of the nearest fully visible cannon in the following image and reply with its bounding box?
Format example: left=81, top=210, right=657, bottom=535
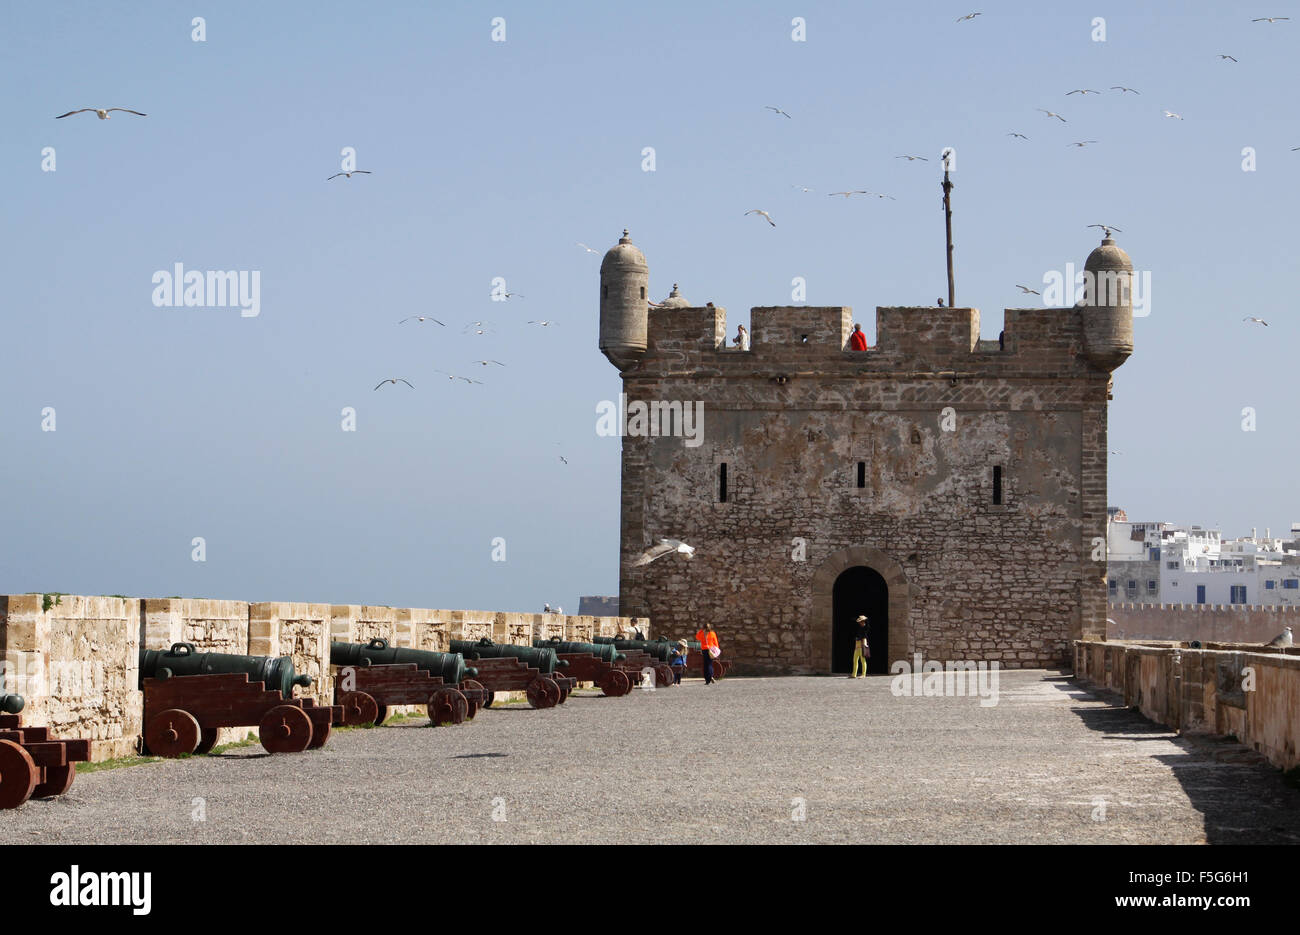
left=143, top=672, right=343, bottom=757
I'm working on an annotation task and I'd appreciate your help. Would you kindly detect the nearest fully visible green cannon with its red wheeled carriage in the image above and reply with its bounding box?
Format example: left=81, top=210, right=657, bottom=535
left=140, top=642, right=343, bottom=757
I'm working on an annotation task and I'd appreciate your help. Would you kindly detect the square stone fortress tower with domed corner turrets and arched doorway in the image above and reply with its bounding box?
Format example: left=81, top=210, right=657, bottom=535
left=601, top=231, right=1132, bottom=674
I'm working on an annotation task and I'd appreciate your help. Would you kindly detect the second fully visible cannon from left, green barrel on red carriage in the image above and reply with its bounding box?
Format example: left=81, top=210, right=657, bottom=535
left=329, top=639, right=488, bottom=727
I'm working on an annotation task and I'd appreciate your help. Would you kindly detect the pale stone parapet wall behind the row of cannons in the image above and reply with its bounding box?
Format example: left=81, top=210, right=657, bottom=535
left=0, top=594, right=650, bottom=761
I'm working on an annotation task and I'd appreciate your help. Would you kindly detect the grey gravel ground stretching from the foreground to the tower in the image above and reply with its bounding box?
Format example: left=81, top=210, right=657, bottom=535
left=0, top=670, right=1300, bottom=844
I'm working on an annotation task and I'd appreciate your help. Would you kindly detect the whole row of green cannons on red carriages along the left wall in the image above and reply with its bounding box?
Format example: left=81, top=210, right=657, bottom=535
left=0, top=637, right=722, bottom=809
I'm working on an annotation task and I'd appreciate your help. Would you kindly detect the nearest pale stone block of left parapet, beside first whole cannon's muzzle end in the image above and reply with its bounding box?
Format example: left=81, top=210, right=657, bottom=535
left=0, top=594, right=143, bottom=761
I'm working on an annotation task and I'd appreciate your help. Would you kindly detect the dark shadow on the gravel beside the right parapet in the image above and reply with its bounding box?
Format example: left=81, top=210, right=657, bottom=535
left=1045, top=676, right=1300, bottom=844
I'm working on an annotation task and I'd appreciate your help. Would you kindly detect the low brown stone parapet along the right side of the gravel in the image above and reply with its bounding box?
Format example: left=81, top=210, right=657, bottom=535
left=1074, top=640, right=1300, bottom=770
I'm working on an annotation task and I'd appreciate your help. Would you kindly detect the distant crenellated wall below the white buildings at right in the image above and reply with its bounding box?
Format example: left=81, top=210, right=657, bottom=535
left=1106, top=603, right=1300, bottom=644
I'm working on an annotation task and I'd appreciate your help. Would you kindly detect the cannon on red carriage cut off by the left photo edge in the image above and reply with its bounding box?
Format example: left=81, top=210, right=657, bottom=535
left=0, top=712, right=90, bottom=809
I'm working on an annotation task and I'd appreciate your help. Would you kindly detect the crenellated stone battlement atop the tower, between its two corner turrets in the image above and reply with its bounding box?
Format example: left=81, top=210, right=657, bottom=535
left=638, top=306, right=1101, bottom=376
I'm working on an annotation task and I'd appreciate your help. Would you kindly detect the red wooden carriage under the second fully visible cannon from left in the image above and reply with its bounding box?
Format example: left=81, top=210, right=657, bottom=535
left=334, top=662, right=488, bottom=727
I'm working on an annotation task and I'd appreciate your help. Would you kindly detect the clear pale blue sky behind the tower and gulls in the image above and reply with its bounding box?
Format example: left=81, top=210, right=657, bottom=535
left=0, top=0, right=1300, bottom=610
